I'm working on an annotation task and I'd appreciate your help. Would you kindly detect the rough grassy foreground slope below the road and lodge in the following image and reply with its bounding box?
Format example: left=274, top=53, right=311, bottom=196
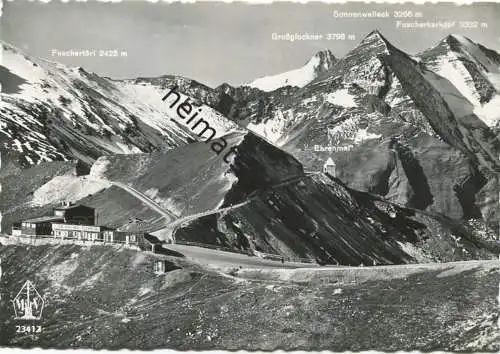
left=0, top=245, right=500, bottom=352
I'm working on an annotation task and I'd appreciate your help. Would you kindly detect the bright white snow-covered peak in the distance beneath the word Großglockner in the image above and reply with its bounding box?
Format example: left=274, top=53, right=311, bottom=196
left=247, top=49, right=336, bottom=92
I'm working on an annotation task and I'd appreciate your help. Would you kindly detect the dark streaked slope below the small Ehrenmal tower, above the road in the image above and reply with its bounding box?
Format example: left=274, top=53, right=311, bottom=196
left=175, top=174, right=500, bottom=265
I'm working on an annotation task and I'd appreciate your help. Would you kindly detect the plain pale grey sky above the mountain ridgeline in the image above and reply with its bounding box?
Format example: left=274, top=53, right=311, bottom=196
left=1, top=0, right=500, bottom=86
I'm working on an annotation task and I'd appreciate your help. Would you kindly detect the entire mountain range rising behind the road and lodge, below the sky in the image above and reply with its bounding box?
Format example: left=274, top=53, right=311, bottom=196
left=0, top=31, right=500, bottom=265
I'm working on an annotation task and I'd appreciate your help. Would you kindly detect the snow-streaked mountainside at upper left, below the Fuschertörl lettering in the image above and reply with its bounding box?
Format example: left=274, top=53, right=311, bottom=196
left=0, top=43, right=237, bottom=164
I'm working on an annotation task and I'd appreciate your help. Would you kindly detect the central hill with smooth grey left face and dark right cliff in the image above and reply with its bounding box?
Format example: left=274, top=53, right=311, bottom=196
left=90, top=132, right=303, bottom=220
